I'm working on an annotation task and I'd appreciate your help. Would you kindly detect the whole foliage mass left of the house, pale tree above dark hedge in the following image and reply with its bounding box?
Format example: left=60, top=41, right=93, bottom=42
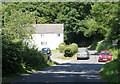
left=2, top=6, right=49, bottom=77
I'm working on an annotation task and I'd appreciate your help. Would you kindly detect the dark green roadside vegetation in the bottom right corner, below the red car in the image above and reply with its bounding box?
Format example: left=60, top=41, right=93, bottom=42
left=100, top=60, right=120, bottom=84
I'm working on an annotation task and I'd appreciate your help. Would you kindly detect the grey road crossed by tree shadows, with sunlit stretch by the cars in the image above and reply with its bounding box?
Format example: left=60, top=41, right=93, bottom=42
left=9, top=48, right=106, bottom=84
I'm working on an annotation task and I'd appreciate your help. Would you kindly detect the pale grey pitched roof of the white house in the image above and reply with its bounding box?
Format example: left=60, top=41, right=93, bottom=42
left=33, top=24, right=64, bottom=34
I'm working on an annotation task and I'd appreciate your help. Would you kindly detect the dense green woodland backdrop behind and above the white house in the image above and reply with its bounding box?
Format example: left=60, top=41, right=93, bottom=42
left=2, top=2, right=120, bottom=46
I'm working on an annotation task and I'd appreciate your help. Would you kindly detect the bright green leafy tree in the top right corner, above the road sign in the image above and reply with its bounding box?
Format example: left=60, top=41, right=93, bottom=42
left=91, top=2, right=120, bottom=40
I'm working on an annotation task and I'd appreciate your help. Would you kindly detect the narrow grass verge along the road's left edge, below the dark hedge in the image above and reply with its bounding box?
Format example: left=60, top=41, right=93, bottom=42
left=2, top=60, right=58, bottom=84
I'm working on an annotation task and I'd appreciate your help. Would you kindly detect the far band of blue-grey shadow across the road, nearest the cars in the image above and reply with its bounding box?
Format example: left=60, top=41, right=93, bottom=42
left=41, top=63, right=104, bottom=72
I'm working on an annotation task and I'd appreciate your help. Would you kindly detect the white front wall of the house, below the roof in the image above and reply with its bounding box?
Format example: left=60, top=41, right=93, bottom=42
left=32, top=33, right=64, bottom=50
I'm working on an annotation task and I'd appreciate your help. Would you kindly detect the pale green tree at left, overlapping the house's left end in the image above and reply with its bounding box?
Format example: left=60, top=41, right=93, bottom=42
left=2, top=10, right=35, bottom=40
